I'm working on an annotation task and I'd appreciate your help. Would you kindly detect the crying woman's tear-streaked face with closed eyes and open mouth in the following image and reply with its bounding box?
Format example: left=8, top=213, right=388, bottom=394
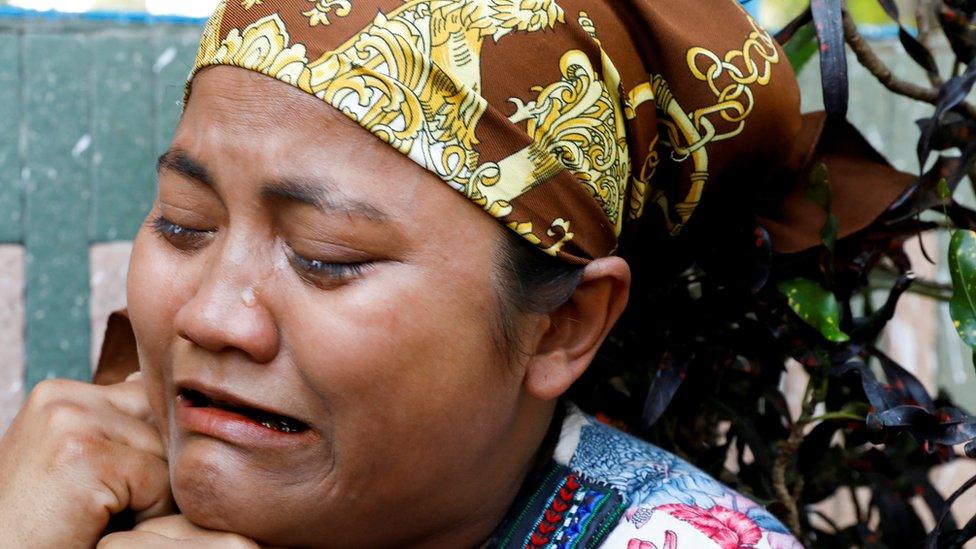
left=128, top=67, right=545, bottom=546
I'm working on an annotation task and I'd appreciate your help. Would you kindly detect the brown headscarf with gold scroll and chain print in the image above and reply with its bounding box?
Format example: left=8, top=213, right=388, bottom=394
left=188, top=0, right=800, bottom=263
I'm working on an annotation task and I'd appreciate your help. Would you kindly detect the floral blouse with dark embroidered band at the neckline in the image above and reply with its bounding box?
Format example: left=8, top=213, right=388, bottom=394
left=490, top=406, right=802, bottom=549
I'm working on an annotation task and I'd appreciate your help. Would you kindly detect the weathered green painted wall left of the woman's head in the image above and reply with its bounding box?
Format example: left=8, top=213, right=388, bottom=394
left=0, top=15, right=201, bottom=389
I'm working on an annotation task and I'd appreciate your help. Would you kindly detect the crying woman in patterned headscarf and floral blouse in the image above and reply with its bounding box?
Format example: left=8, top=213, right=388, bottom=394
left=0, top=0, right=803, bottom=549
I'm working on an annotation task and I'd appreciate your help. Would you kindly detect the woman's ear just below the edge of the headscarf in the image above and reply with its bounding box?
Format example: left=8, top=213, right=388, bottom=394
left=523, top=257, right=630, bottom=401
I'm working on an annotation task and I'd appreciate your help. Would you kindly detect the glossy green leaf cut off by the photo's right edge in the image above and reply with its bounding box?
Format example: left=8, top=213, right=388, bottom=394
left=949, top=231, right=976, bottom=347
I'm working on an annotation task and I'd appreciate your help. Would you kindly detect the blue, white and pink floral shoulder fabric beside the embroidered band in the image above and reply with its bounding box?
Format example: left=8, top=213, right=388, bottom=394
left=554, top=407, right=801, bottom=549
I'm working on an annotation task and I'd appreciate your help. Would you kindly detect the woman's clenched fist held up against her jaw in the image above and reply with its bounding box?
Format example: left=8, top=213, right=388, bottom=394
left=0, top=374, right=172, bottom=548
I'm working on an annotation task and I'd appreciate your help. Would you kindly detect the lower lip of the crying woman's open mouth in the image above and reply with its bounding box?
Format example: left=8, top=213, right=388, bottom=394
left=175, top=397, right=314, bottom=449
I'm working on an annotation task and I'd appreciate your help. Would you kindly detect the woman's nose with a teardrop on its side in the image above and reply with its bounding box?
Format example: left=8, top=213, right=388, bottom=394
left=174, top=242, right=279, bottom=364
